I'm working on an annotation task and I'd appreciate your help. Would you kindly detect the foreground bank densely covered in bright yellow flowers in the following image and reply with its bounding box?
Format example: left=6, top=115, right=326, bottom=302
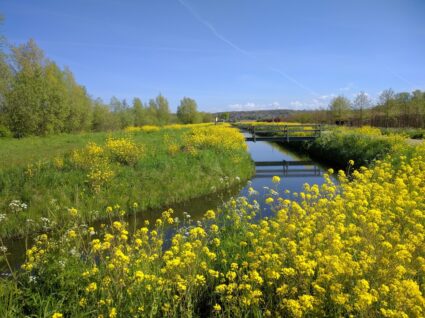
left=0, top=134, right=425, bottom=317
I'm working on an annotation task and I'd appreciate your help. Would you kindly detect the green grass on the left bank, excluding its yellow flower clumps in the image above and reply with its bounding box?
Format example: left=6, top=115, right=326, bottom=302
left=0, top=129, right=253, bottom=237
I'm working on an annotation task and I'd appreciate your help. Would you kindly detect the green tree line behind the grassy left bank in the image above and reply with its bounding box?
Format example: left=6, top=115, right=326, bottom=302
left=0, top=33, right=212, bottom=137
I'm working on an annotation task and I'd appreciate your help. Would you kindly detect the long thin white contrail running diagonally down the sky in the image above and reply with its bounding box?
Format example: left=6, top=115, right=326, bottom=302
left=177, top=0, right=319, bottom=96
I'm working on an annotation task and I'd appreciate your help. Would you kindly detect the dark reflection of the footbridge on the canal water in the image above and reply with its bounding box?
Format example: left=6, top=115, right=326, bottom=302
left=255, top=160, right=321, bottom=178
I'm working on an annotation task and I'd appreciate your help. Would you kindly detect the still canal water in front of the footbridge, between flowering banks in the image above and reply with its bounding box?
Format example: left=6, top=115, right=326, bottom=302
left=0, top=135, right=329, bottom=272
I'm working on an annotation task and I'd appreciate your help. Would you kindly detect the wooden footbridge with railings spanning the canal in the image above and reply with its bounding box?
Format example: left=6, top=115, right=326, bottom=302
left=245, top=124, right=322, bottom=142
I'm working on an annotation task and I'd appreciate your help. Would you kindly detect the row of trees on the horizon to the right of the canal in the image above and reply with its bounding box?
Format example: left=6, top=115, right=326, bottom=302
left=288, top=89, right=425, bottom=128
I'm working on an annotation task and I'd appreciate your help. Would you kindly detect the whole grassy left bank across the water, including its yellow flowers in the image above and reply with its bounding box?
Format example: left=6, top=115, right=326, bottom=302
left=0, top=125, right=253, bottom=237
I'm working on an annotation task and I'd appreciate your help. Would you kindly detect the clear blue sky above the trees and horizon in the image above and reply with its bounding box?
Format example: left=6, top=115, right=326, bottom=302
left=0, top=0, right=425, bottom=112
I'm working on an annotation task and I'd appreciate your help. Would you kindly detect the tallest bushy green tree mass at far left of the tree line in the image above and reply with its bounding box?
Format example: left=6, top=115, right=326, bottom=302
left=0, top=40, right=96, bottom=137
